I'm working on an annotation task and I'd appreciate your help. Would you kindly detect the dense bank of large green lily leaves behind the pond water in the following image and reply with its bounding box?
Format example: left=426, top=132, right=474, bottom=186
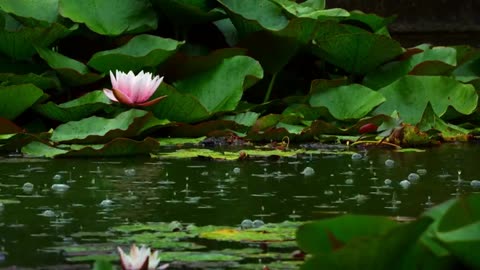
left=0, top=0, right=480, bottom=157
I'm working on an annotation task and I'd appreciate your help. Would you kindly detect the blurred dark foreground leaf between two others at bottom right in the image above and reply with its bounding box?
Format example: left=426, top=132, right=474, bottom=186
left=300, top=216, right=432, bottom=270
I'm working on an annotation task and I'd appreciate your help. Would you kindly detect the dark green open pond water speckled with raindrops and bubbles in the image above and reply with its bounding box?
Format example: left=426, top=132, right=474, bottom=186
left=0, top=144, right=480, bottom=269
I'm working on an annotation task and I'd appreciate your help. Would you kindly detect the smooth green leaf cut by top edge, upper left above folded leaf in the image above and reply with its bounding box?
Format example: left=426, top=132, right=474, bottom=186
left=60, top=0, right=157, bottom=36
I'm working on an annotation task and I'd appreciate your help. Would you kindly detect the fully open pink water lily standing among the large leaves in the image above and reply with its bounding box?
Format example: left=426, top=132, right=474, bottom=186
left=103, top=70, right=166, bottom=107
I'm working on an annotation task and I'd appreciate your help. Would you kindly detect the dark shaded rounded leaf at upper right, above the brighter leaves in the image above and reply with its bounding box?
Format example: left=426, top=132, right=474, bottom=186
left=312, top=21, right=403, bottom=74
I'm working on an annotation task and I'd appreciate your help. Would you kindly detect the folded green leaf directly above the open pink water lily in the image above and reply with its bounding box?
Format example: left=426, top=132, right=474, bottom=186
left=88, top=35, right=184, bottom=73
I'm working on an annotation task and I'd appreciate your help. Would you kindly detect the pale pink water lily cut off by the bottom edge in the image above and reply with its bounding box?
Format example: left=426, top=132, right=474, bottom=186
left=117, top=244, right=168, bottom=270
